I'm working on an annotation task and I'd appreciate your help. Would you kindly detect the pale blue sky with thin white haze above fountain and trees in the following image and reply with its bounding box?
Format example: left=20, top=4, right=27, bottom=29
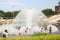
left=0, top=0, right=59, bottom=11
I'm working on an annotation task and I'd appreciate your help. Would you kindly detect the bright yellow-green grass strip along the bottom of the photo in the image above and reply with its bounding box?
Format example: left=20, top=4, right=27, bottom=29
left=0, top=33, right=60, bottom=40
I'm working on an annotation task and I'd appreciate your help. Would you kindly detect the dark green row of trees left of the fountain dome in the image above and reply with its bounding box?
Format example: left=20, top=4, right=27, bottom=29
left=0, top=10, right=20, bottom=19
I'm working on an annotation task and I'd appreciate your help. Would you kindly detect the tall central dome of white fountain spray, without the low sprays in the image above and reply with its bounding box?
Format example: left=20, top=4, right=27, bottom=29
left=13, top=8, right=47, bottom=27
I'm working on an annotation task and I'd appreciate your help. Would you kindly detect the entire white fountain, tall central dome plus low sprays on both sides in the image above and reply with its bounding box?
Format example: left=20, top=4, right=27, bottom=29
left=0, top=8, right=58, bottom=35
